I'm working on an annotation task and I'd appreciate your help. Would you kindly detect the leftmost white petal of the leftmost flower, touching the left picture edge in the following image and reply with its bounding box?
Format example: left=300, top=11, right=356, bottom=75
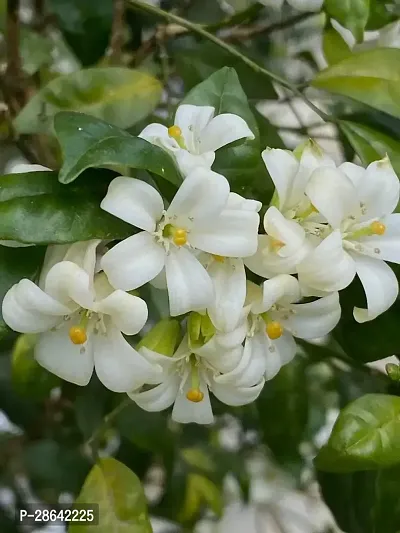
left=2, top=279, right=69, bottom=333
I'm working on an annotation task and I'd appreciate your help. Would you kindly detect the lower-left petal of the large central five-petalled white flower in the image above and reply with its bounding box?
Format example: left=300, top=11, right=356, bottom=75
left=101, top=231, right=165, bottom=291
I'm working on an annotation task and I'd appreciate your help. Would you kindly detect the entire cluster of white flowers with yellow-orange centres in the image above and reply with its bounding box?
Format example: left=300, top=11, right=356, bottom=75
left=3, top=105, right=400, bottom=424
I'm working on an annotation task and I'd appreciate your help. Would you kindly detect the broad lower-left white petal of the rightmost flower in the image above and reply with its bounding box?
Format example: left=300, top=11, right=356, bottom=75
left=297, top=231, right=356, bottom=292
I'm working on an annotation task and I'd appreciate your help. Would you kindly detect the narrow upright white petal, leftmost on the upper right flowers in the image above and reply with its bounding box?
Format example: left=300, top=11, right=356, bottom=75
left=261, top=148, right=299, bottom=209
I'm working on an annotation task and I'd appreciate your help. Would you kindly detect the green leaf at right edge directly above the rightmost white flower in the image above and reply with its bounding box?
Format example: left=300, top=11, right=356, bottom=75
left=340, top=120, right=400, bottom=176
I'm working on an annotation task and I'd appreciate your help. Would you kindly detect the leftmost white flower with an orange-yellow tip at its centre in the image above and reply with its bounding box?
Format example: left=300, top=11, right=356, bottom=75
left=3, top=241, right=155, bottom=392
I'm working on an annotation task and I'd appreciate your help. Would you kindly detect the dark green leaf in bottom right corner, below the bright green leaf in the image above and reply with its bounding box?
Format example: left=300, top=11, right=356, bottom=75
left=318, top=467, right=400, bottom=533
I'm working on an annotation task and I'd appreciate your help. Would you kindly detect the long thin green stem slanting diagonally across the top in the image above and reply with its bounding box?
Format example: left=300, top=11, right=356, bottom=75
left=127, top=0, right=335, bottom=122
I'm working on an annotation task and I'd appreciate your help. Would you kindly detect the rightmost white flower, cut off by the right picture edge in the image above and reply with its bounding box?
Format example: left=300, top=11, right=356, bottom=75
left=298, top=158, right=400, bottom=322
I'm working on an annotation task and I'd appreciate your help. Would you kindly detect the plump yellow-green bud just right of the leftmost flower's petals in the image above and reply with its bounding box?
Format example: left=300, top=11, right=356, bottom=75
left=137, top=318, right=181, bottom=357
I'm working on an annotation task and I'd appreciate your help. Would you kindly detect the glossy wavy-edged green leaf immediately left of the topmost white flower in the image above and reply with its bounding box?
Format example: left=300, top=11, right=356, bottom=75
left=54, top=112, right=182, bottom=185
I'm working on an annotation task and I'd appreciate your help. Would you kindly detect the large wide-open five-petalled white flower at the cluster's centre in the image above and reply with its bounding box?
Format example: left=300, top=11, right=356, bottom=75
left=101, top=168, right=261, bottom=316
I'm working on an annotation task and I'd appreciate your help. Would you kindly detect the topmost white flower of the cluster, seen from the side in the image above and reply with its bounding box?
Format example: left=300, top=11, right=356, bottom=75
left=139, top=104, right=254, bottom=176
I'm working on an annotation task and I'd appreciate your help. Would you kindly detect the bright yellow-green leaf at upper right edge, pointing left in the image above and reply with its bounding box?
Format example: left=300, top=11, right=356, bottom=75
left=312, top=48, right=400, bottom=117
